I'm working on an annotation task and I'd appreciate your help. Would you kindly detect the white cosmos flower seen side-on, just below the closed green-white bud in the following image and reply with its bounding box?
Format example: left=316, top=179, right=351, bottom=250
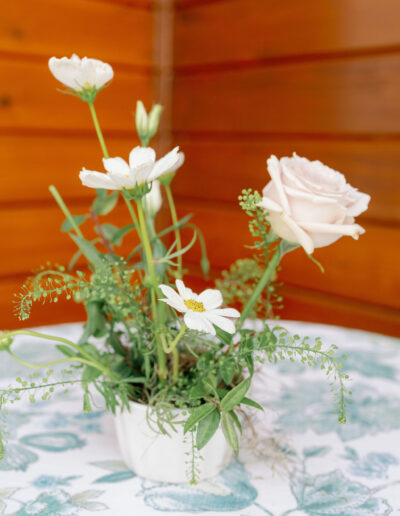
left=79, top=147, right=183, bottom=190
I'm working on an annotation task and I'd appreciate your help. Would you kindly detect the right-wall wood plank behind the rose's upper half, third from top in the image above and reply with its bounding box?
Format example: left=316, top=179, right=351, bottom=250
left=173, top=136, right=400, bottom=223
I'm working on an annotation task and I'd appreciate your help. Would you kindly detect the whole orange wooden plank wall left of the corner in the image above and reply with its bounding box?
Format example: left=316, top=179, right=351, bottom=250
left=0, top=0, right=158, bottom=328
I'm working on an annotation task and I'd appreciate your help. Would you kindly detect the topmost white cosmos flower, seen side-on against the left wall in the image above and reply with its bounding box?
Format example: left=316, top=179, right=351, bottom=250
left=49, top=54, right=114, bottom=91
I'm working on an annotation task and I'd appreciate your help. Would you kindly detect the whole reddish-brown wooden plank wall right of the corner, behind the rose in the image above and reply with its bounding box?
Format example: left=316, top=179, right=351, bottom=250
left=172, top=0, right=400, bottom=334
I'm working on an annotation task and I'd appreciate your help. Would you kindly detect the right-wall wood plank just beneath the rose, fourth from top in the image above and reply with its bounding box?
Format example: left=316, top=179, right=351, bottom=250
left=177, top=198, right=400, bottom=308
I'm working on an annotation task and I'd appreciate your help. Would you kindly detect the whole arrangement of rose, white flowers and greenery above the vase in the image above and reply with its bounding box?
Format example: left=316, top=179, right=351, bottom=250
left=0, top=55, right=369, bottom=482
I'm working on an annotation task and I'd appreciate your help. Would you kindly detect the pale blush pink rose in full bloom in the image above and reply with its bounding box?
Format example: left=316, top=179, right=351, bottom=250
left=260, top=153, right=370, bottom=254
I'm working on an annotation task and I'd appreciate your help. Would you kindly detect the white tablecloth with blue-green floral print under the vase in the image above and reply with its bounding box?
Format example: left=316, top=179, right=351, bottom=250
left=0, top=322, right=400, bottom=516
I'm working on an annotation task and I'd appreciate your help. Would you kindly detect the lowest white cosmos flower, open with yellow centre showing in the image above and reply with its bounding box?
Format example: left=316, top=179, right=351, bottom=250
left=160, top=279, right=240, bottom=335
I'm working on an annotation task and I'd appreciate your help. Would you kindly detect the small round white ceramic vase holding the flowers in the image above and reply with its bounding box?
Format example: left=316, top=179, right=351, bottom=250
left=115, top=402, right=232, bottom=483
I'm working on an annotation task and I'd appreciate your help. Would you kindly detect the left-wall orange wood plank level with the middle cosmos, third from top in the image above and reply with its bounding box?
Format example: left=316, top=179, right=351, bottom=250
left=0, top=134, right=139, bottom=204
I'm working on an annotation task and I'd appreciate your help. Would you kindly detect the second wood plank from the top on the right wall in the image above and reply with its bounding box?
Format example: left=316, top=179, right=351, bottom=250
left=173, top=55, right=400, bottom=135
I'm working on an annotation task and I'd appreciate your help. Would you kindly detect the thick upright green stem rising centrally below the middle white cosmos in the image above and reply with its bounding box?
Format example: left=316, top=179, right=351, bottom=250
left=136, top=199, right=167, bottom=380
